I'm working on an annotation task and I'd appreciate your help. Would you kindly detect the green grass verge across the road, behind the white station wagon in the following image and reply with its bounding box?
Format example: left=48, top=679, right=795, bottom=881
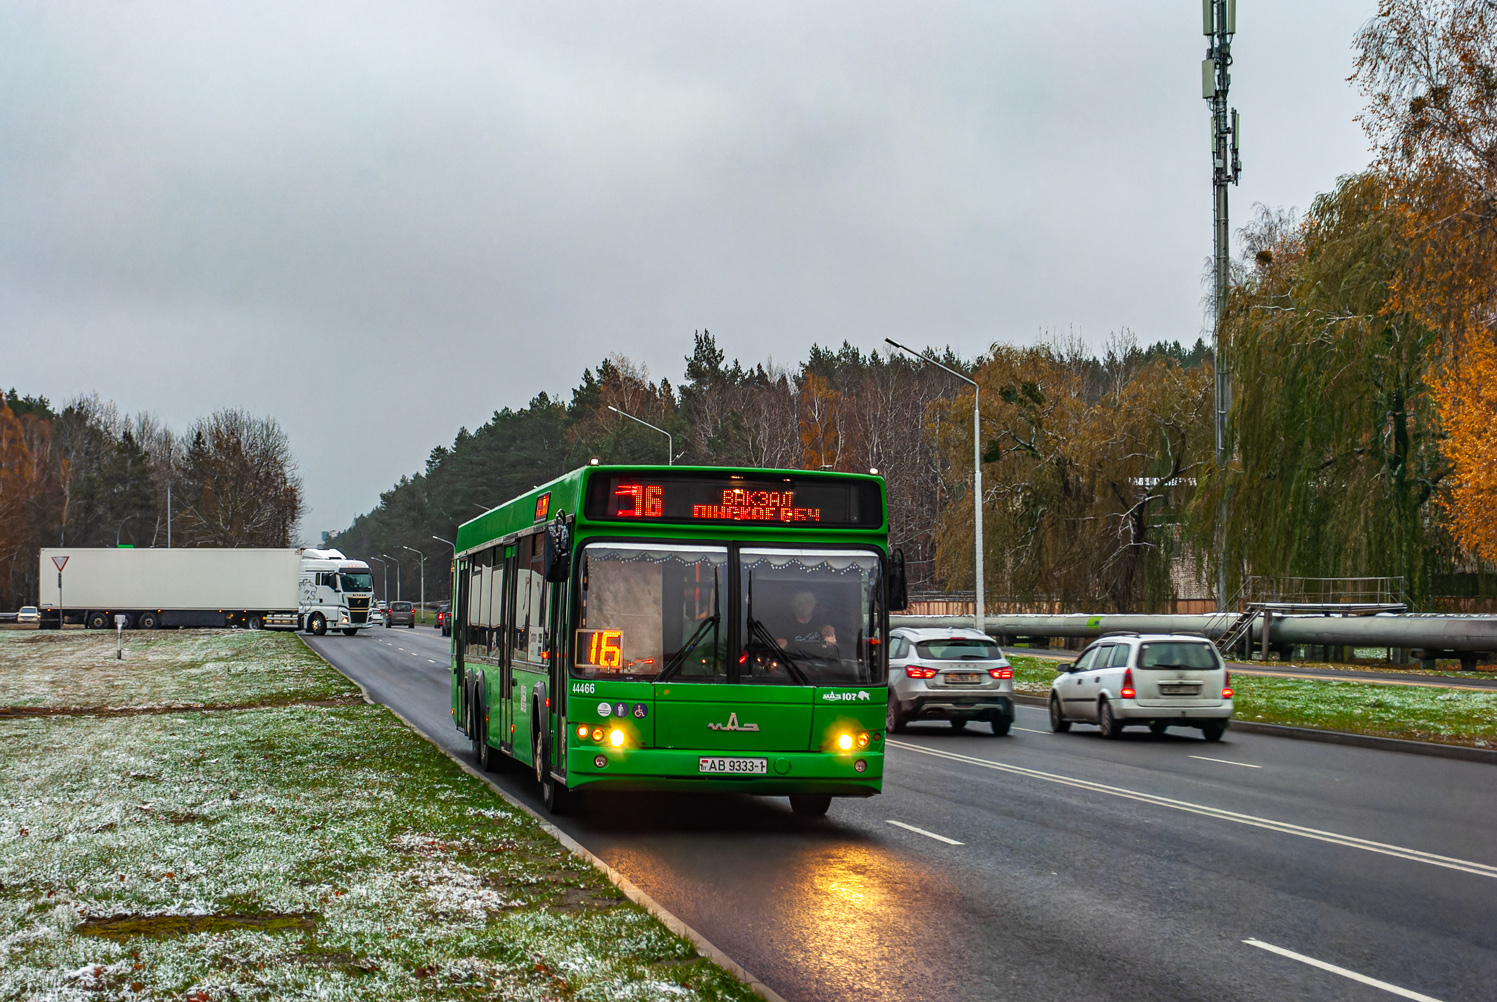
left=1009, top=656, right=1497, bottom=747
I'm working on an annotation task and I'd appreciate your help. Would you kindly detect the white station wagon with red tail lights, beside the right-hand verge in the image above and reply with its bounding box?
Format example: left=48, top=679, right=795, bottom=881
left=1049, top=634, right=1232, bottom=741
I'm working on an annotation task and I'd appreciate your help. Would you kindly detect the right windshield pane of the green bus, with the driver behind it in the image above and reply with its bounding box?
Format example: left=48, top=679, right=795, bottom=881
left=738, top=548, right=885, bottom=686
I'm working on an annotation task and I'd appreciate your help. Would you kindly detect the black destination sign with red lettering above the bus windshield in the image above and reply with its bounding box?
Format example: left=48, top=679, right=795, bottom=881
left=587, top=470, right=883, bottom=529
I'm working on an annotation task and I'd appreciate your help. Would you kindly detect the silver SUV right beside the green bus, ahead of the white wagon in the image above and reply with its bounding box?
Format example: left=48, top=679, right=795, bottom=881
left=886, top=626, right=1013, bottom=735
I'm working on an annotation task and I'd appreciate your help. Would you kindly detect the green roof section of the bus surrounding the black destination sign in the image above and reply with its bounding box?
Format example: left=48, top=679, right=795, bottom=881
left=455, top=464, right=889, bottom=556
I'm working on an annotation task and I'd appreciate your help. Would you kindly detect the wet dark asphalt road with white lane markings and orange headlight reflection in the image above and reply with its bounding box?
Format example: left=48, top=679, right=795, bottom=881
left=308, top=628, right=1497, bottom=1002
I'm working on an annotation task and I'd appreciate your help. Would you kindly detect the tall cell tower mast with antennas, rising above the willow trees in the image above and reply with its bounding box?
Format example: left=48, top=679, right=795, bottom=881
left=1201, top=0, right=1243, bottom=613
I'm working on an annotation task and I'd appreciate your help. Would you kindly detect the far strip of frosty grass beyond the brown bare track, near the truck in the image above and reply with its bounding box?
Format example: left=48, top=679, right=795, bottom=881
left=0, top=629, right=358, bottom=710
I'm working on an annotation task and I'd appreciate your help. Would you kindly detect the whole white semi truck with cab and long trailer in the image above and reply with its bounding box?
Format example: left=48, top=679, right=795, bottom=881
left=40, top=547, right=374, bottom=637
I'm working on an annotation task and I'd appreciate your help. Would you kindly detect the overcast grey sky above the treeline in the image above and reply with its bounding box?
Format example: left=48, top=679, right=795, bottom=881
left=0, top=0, right=1374, bottom=539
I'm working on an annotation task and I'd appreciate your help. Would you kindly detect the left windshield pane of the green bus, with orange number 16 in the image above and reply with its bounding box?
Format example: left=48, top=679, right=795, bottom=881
left=572, top=542, right=728, bottom=681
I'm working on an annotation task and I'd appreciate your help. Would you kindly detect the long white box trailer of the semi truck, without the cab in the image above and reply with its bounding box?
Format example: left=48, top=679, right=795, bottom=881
left=40, top=547, right=301, bottom=629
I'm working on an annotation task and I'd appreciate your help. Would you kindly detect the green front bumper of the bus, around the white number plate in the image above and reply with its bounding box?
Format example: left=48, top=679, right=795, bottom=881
left=567, top=743, right=883, bottom=797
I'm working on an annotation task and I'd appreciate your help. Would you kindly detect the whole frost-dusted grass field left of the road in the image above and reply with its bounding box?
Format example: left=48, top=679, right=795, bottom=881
left=0, top=634, right=751, bottom=1002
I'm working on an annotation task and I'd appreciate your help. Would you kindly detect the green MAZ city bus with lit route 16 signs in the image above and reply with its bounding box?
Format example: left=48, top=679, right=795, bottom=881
left=452, top=466, right=904, bottom=815
